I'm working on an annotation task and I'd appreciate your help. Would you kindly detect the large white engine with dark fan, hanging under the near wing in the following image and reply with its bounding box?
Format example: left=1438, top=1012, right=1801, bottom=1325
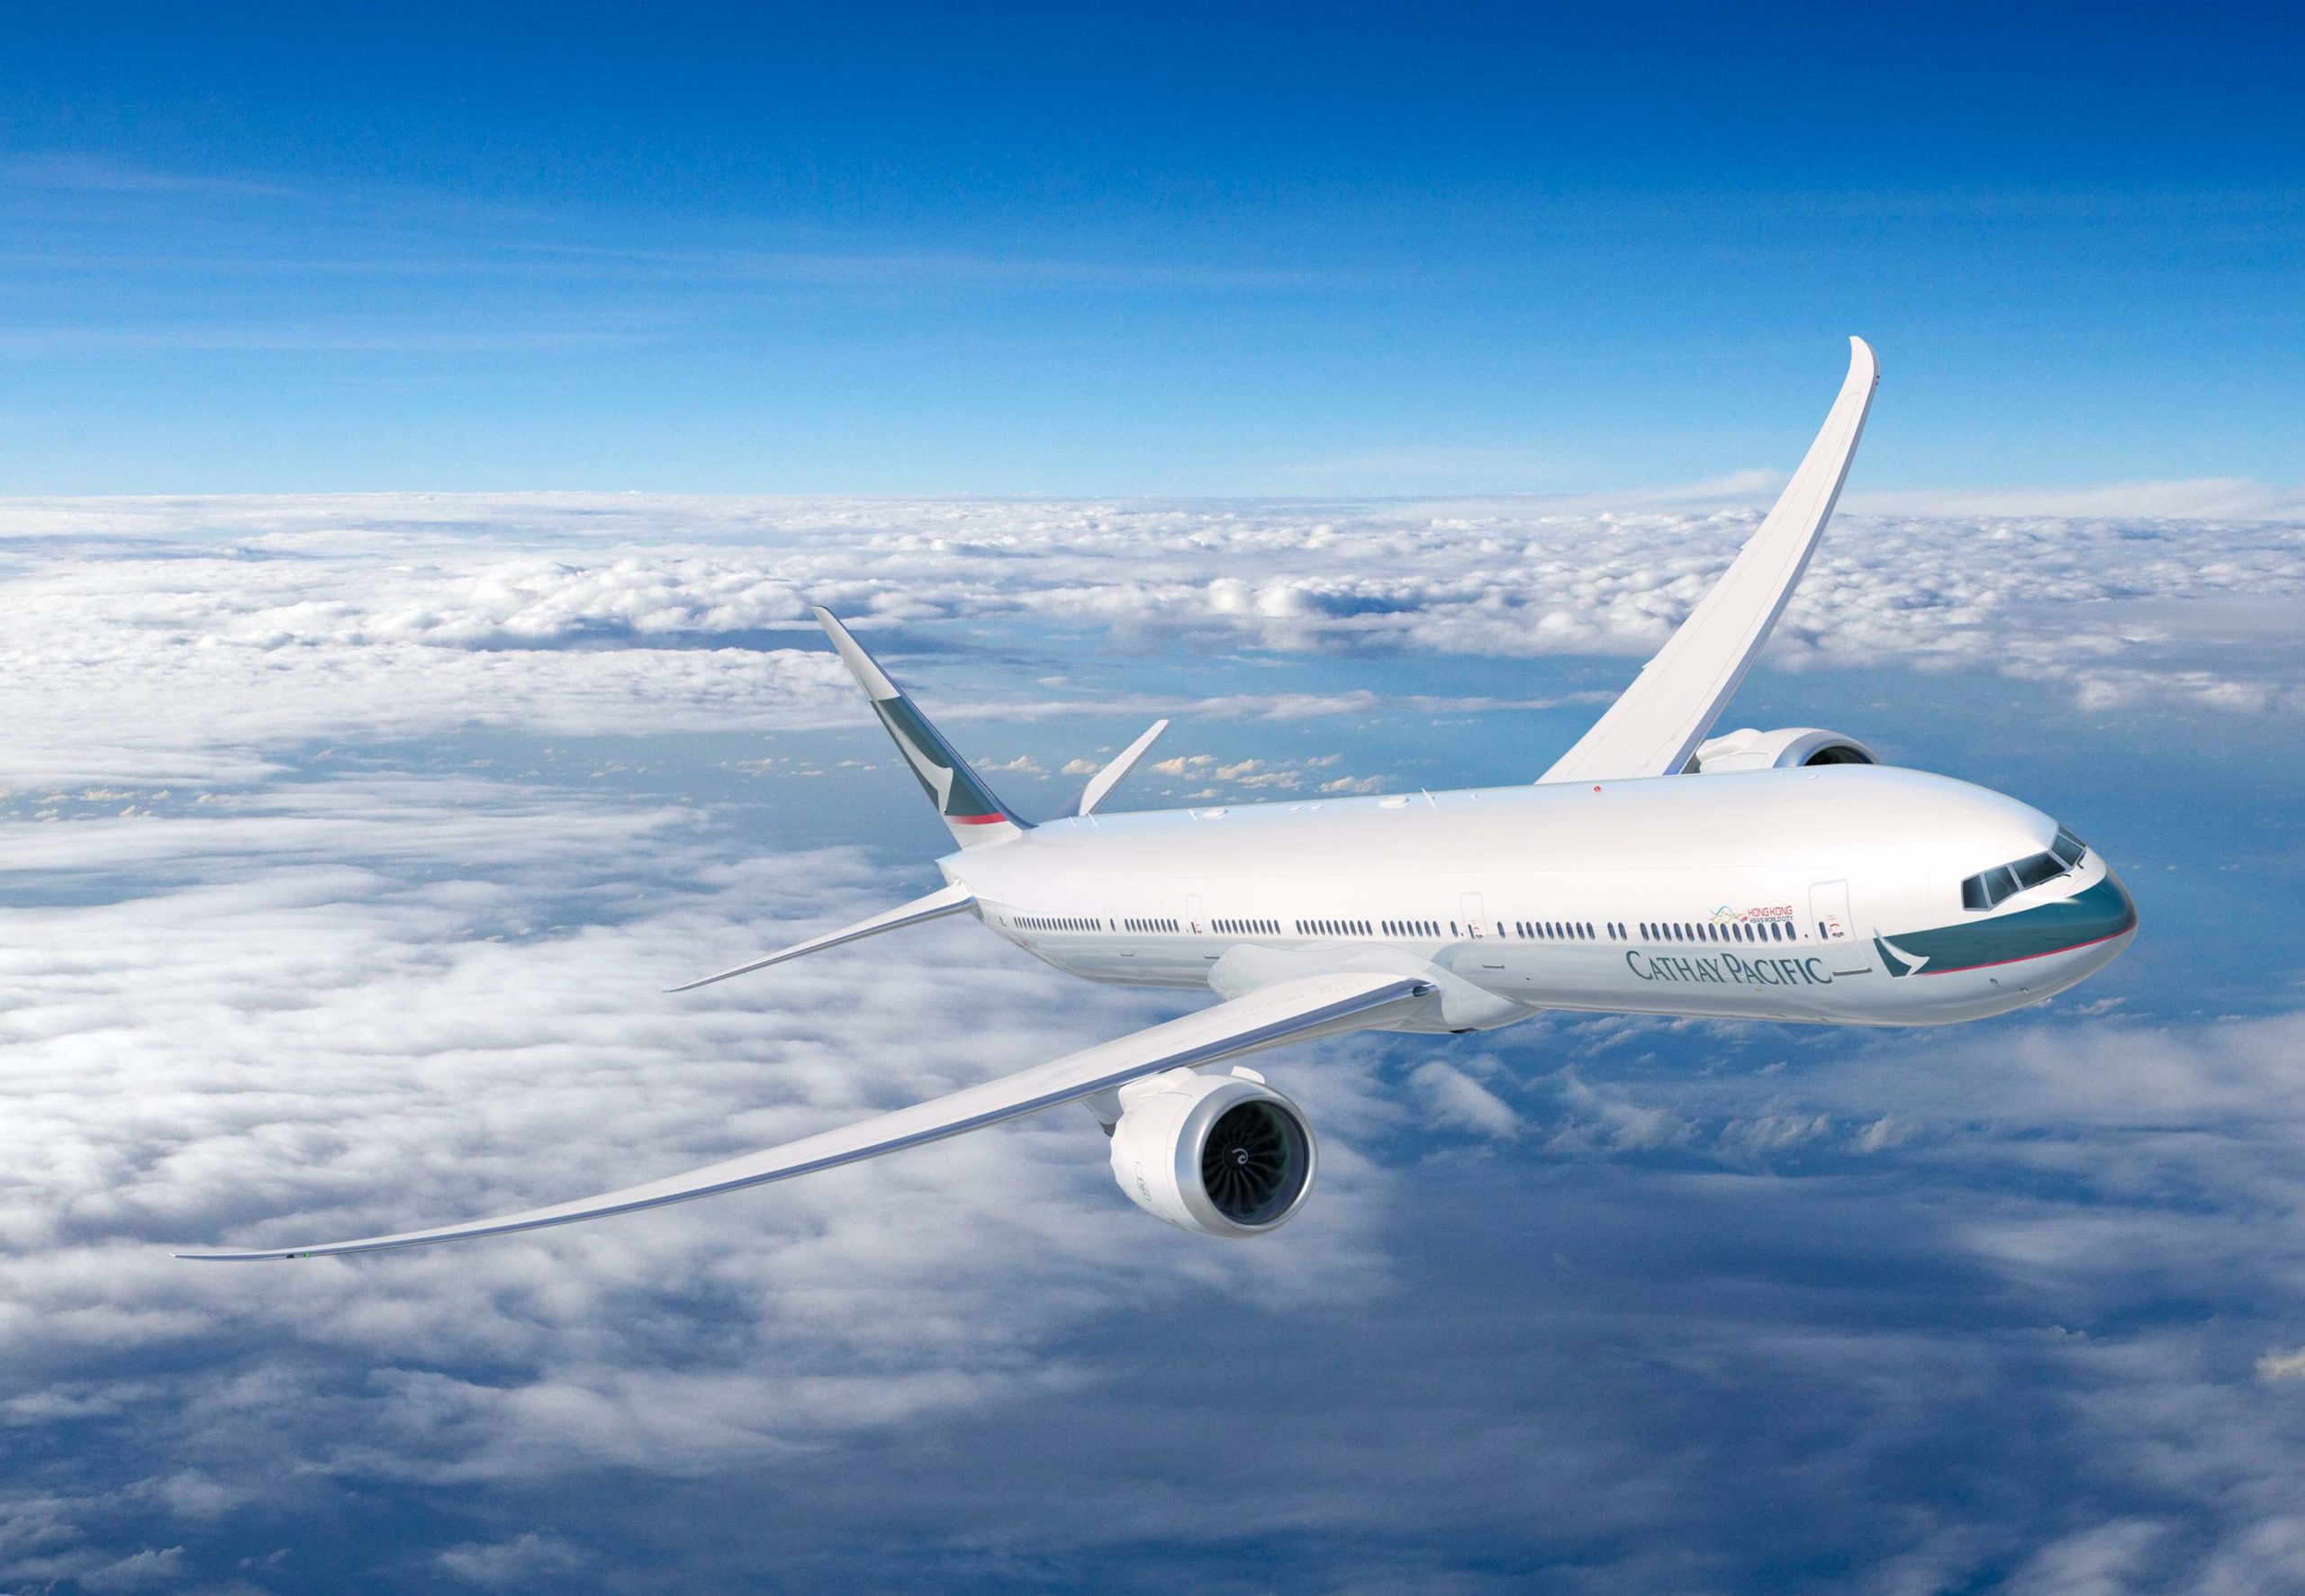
left=1113, top=1069, right=1318, bottom=1239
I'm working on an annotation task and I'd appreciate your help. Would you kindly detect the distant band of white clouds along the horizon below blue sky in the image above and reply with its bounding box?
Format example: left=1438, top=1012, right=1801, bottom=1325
left=0, top=493, right=2305, bottom=783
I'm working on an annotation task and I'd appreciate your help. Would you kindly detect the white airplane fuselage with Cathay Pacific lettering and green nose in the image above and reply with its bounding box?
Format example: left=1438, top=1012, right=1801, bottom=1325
left=940, top=764, right=2137, bottom=1030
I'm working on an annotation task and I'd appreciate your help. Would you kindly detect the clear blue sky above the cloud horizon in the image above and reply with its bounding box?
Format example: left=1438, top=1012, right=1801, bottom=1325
left=0, top=5, right=2305, bottom=495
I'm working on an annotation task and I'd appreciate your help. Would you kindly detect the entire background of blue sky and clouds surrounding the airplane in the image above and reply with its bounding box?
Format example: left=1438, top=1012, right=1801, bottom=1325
left=0, top=7, right=2305, bottom=1596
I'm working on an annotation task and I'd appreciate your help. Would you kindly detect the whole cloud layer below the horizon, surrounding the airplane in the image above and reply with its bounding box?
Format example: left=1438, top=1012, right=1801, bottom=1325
left=0, top=495, right=2305, bottom=1591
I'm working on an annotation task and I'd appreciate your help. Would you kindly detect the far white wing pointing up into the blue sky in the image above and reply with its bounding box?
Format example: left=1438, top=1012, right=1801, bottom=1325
left=1538, top=338, right=1881, bottom=783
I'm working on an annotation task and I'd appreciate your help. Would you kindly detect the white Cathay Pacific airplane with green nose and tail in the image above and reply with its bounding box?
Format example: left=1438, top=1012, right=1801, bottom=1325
left=180, top=338, right=2137, bottom=1262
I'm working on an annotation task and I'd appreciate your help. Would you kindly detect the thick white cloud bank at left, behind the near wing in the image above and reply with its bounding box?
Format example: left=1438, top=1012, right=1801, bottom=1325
left=0, top=755, right=1383, bottom=1589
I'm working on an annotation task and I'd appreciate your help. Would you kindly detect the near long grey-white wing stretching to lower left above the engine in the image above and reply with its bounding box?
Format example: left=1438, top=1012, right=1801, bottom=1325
left=177, top=974, right=1432, bottom=1262
